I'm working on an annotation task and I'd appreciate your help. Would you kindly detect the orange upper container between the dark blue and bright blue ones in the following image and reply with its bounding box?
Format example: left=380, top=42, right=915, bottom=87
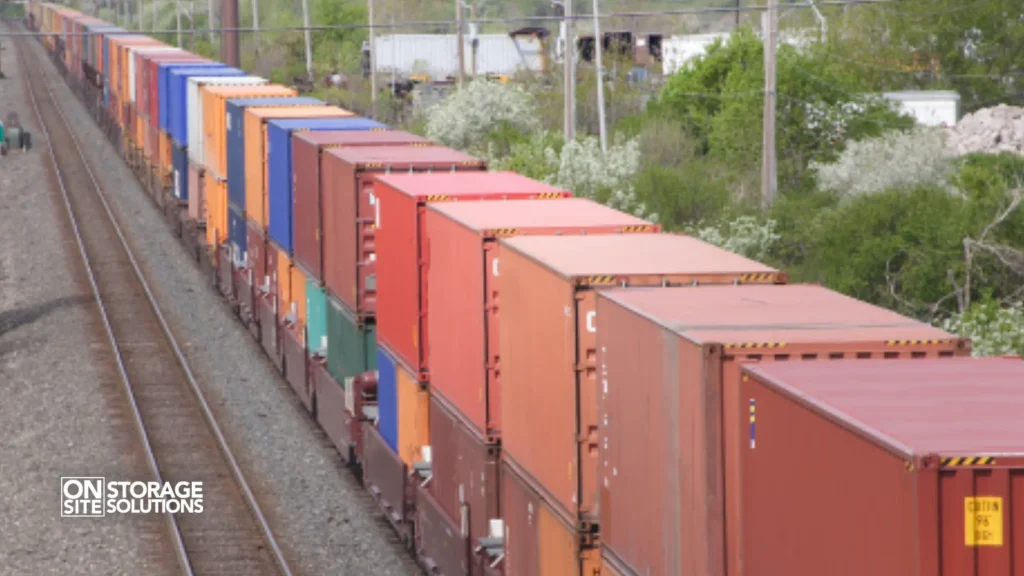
left=245, top=106, right=354, bottom=230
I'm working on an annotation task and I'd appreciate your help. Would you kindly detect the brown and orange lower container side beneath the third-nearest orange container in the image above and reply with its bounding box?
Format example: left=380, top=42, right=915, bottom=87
left=501, top=462, right=601, bottom=576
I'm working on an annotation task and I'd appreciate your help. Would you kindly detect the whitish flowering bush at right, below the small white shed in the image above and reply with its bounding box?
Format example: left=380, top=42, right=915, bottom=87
left=810, top=128, right=956, bottom=196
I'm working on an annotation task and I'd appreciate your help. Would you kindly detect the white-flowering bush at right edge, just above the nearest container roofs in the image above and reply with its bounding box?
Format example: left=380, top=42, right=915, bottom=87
left=940, top=299, right=1024, bottom=357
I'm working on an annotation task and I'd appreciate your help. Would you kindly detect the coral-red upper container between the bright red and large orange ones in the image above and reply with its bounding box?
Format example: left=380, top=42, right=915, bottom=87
left=426, top=198, right=662, bottom=441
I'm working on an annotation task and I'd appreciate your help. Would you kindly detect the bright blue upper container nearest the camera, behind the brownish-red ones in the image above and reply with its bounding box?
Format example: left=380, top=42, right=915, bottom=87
left=266, top=118, right=387, bottom=254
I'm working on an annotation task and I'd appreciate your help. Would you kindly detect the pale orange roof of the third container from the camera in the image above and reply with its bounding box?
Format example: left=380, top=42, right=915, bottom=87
left=501, top=234, right=777, bottom=277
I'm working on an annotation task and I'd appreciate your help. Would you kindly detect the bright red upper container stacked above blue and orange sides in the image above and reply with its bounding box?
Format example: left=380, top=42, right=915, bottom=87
left=372, top=172, right=571, bottom=381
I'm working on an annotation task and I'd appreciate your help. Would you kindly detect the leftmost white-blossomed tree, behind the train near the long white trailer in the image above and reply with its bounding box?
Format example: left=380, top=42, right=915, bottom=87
left=426, top=79, right=541, bottom=151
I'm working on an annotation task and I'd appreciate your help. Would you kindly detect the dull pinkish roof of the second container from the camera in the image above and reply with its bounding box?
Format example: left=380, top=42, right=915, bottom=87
left=600, top=284, right=954, bottom=344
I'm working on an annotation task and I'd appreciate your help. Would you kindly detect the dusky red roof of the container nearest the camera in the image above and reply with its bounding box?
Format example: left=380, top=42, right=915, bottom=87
left=744, top=358, right=1024, bottom=456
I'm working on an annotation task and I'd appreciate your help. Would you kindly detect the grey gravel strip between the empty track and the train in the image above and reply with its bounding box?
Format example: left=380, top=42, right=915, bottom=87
left=24, top=24, right=420, bottom=575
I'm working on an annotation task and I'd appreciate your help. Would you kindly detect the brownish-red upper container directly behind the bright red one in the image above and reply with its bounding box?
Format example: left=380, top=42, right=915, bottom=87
left=315, top=146, right=487, bottom=320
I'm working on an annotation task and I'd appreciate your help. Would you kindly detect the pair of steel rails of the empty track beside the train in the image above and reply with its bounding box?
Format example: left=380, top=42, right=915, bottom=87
left=15, top=25, right=292, bottom=576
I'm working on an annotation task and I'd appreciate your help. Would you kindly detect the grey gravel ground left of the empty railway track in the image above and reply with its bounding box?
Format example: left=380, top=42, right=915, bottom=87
left=0, top=25, right=173, bottom=575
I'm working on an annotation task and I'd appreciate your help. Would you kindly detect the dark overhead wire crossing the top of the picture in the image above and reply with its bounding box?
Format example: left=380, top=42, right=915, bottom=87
left=0, top=0, right=907, bottom=37
